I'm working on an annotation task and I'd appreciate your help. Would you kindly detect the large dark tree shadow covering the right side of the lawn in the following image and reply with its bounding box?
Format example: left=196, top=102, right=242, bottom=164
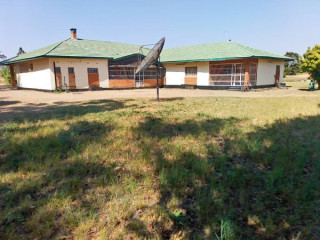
left=132, top=116, right=320, bottom=239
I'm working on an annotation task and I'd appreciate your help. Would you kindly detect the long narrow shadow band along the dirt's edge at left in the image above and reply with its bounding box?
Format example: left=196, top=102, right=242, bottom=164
left=0, top=100, right=134, bottom=123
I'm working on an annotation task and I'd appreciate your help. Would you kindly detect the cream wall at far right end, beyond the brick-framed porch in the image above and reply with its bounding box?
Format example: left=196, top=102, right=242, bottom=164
left=257, top=59, right=284, bottom=86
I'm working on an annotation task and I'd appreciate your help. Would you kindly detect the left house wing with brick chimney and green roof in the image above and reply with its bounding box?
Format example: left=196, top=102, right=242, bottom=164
left=3, top=28, right=163, bottom=90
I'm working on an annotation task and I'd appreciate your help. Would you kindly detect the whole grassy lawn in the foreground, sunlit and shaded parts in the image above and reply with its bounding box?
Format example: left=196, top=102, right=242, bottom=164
left=0, top=97, right=320, bottom=239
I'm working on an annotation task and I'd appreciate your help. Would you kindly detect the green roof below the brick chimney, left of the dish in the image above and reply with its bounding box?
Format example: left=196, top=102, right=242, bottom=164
left=2, top=39, right=150, bottom=64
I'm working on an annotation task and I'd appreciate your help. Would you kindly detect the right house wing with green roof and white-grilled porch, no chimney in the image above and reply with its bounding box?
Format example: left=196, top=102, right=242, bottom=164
left=161, top=41, right=292, bottom=89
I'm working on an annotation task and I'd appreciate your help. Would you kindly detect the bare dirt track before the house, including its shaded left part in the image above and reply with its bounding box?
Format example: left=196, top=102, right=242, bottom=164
left=0, top=86, right=320, bottom=122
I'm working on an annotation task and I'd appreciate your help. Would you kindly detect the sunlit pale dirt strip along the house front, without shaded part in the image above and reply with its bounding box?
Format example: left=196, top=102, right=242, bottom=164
left=0, top=85, right=320, bottom=104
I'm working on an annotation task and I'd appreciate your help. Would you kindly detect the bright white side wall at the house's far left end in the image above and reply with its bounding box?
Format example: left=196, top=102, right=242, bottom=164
left=14, top=58, right=55, bottom=90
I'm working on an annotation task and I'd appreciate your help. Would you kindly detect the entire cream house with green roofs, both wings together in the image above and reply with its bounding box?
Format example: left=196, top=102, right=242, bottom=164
left=2, top=28, right=291, bottom=91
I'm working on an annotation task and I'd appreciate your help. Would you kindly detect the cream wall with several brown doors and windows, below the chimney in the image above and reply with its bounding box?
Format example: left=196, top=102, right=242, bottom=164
left=50, top=58, right=109, bottom=89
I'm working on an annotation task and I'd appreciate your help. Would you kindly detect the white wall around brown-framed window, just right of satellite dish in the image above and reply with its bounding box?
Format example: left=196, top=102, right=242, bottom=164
left=164, top=62, right=209, bottom=86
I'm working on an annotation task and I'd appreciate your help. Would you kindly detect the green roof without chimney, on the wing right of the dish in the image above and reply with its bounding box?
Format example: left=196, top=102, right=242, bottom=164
left=160, top=41, right=292, bottom=63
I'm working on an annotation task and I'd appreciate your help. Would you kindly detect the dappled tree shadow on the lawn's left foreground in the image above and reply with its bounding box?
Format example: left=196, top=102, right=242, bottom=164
left=0, top=121, right=117, bottom=239
